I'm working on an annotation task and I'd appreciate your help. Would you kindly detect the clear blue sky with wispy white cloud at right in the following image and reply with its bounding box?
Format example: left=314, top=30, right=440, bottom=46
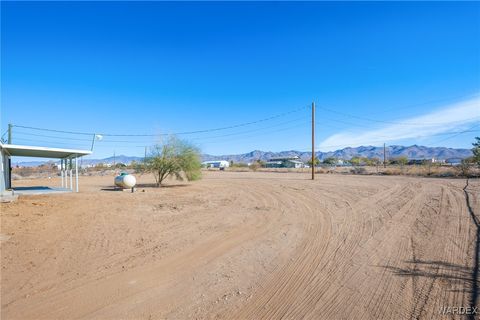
left=1, top=2, right=480, bottom=158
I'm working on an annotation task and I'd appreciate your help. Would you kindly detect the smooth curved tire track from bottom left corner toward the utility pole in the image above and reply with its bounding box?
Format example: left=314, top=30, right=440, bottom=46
left=1, top=176, right=310, bottom=319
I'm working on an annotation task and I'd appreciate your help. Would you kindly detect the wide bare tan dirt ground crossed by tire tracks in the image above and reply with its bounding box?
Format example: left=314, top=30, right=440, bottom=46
left=0, top=172, right=480, bottom=319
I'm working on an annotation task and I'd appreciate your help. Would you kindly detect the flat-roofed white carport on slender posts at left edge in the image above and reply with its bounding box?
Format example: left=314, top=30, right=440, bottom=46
left=0, top=143, right=92, bottom=195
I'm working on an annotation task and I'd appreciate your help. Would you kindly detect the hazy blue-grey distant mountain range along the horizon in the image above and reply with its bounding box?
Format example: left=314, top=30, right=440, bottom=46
left=12, top=145, right=472, bottom=167
